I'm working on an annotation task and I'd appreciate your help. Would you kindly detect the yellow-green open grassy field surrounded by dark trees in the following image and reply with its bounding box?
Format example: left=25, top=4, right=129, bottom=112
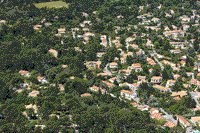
left=35, top=1, right=69, bottom=8
